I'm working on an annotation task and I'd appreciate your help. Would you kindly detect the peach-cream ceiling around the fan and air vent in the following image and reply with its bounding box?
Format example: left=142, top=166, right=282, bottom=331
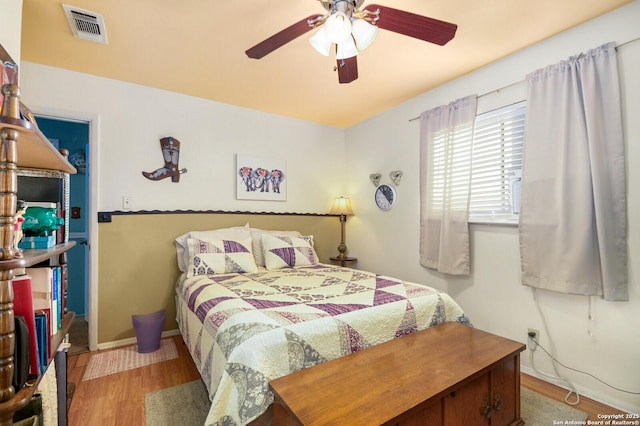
left=21, top=0, right=632, bottom=128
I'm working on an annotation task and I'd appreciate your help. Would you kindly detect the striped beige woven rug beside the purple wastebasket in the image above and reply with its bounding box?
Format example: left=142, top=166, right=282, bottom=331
left=82, top=339, right=178, bottom=380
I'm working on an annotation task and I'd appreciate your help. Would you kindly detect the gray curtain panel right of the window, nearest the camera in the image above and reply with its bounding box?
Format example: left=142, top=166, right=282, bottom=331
left=519, top=43, right=628, bottom=300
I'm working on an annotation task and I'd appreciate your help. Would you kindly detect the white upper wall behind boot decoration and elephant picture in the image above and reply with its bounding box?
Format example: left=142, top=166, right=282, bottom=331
left=22, top=62, right=345, bottom=213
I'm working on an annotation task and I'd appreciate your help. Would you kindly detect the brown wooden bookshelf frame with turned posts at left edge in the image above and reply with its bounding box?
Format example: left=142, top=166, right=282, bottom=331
left=0, top=58, right=76, bottom=426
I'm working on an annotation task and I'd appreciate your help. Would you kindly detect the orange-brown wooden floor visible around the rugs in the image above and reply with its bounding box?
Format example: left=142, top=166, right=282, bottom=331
left=68, top=336, right=621, bottom=426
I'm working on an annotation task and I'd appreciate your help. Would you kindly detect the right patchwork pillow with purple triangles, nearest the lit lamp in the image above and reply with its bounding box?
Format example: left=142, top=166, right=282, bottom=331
left=262, top=234, right=318, bottom=271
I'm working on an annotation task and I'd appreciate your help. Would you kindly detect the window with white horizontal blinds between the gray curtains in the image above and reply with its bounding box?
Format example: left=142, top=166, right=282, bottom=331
left=469, top=101, right=526, bottom=223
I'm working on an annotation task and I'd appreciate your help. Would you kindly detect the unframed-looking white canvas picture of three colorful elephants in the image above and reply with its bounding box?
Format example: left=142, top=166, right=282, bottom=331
left=236, top=154, right=288, bottom=201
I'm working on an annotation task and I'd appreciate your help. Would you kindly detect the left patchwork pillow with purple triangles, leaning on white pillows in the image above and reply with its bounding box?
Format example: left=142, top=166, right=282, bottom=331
left=187, top=237, right=258, bottom=277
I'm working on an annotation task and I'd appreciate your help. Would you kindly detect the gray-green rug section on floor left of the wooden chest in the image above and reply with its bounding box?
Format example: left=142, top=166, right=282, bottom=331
left=144, top=380, right=211, bottom=426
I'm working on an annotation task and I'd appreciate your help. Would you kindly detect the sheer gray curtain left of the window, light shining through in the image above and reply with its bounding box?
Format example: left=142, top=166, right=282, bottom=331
left=420, top=95, right=477, bottom=275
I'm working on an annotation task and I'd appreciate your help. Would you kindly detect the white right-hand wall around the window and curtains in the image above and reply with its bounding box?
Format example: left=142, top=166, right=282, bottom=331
left=346, top=1, right=640, bottom=413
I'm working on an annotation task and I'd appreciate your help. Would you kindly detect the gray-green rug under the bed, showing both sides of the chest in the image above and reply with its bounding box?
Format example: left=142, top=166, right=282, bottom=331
left=144, top=380, right=588, bottom=426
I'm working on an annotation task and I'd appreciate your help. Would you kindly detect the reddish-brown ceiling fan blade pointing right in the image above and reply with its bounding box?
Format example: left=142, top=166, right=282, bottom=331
left=365, top=4, right=458, bottom=46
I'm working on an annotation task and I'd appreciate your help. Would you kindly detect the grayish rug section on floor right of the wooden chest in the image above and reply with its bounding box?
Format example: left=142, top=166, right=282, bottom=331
left=520, top=387, right=589, bottom=426
